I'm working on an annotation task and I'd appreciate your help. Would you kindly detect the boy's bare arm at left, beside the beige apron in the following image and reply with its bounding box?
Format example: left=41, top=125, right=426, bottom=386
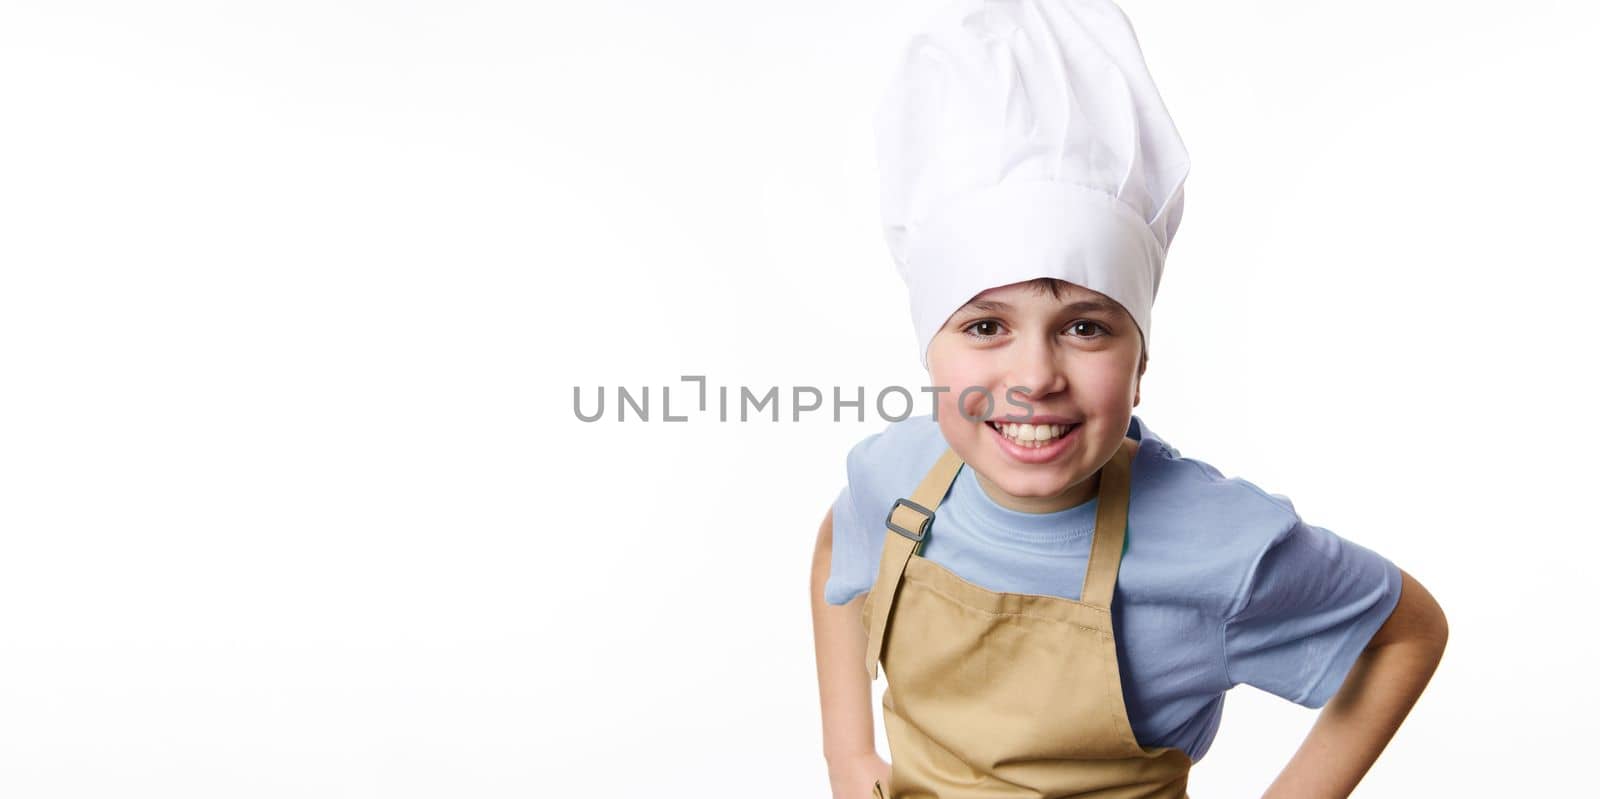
left=811, top=511, right=877, bottom=762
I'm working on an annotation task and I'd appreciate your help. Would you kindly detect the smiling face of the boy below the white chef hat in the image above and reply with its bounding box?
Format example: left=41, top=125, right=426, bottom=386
left=928, top=282, right=1142, bottom=512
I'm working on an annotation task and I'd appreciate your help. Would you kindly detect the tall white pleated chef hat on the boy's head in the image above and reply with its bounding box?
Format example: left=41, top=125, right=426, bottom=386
left=877, top=0, right=1189, bottom=367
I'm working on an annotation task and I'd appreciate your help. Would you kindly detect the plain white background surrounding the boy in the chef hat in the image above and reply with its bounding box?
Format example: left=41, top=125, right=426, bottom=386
left=0, top=0, right=1600, bottom=799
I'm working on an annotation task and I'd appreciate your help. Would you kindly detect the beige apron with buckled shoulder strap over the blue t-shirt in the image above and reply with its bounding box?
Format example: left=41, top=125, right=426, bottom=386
left=862, top=439, right=1190, bottom=799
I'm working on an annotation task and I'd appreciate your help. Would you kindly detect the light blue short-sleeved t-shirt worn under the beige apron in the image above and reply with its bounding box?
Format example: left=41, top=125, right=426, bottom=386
left=824, top=415, right=1400, bottom=761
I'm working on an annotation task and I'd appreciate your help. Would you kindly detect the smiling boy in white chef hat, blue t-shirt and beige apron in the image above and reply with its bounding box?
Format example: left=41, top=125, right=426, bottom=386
left=811, top=0, right=1446, bottom=799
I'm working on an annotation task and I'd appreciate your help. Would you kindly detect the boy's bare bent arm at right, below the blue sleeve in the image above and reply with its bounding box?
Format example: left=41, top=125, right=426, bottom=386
left=1260, top=570, right=1450, bottom=799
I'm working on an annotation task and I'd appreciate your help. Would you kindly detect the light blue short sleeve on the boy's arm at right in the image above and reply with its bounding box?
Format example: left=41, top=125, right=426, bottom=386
left=1222, top=519, right=1400, bottom=708
